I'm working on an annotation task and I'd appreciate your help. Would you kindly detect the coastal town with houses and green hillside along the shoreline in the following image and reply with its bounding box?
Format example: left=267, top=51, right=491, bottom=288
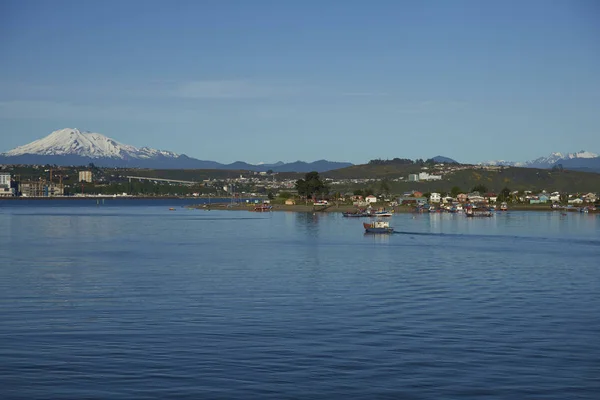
left=0, top=163, right=599, bottom=207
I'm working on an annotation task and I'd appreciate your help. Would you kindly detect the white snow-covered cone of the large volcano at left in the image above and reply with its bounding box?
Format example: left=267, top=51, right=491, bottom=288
left=5, top=128, right=178, bottom=160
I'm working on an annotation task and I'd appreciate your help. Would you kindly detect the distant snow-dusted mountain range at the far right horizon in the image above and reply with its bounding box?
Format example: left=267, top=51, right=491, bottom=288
left=481, top=150, right=600, bottom=172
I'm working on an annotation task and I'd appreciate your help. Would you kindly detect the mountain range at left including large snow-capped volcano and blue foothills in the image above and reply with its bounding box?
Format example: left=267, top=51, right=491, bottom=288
left=0, top=128, right=352, bottom=172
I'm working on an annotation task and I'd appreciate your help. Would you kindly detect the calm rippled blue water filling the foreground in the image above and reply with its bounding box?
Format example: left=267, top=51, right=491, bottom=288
left=0, top=200, right=600, bottom=400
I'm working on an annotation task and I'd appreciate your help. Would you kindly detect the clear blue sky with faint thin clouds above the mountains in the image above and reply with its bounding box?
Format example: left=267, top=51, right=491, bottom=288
left=0, top=0, right=600, bottom=164
